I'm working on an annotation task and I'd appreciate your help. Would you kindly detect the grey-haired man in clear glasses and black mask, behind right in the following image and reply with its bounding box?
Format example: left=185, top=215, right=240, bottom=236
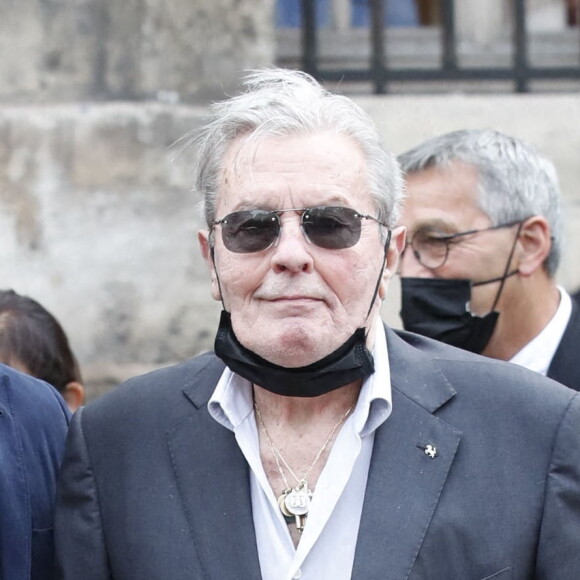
left=399, top=130, right=580, bottom=390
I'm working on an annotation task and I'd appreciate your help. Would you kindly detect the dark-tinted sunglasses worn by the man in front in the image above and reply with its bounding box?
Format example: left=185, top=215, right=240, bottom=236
left=213, top=206, right=386, bottom=254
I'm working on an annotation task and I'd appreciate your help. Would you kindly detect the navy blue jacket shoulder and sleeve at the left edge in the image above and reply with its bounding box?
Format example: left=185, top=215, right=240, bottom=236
left=0, top=364, right=70, bottom=580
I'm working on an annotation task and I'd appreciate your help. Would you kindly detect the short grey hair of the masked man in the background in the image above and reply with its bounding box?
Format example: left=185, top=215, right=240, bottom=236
left=399, top=130, right=562, bottom=276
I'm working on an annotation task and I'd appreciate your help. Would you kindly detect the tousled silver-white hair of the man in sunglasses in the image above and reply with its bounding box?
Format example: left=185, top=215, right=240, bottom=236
left=194, top=69, right=403, bottom=229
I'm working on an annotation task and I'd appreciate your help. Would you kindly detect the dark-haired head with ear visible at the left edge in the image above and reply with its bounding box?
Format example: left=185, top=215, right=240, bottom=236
left=0, top=290, right=85, bottom=411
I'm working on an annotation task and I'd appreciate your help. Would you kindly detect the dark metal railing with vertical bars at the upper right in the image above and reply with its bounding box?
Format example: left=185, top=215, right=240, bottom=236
left=301, top=0, right=580, bottom=94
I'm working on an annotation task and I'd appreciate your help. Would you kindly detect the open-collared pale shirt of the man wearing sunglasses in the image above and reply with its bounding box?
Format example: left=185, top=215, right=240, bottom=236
left=208, top=320, right=392, bottom=580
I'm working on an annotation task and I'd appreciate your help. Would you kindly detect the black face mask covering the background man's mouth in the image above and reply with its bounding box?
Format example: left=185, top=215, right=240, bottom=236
left=401, top=278, right=499, bottom=354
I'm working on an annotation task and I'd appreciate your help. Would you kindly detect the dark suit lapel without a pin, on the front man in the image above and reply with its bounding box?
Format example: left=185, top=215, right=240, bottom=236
left=167, top=363, right=260, bottom=580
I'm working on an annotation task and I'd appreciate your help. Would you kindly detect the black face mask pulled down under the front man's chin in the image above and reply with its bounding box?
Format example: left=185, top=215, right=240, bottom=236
left=214, top=310, right=375, bottom=397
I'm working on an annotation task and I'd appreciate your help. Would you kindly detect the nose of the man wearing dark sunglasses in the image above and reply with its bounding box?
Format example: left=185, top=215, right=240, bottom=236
left=272, top=213, right=313, bottom=272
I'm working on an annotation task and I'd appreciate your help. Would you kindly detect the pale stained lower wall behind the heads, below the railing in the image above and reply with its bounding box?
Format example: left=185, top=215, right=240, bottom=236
left=0, top=95, right=580, bottom=396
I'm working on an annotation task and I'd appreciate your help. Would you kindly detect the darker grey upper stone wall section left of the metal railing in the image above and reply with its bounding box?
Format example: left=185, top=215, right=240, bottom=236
left=0, top=0, right=274, bottom=102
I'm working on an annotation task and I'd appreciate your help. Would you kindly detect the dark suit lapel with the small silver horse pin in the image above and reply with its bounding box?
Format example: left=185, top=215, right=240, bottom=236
left=352, top=331, right=461, bottom=580
